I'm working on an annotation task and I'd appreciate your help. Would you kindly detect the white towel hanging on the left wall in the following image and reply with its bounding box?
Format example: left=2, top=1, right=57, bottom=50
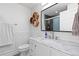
left=0, top=23, right=13, bottom=46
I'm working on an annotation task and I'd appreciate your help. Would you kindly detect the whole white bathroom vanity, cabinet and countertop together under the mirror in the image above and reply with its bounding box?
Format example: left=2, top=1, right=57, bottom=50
left=29, top=37, right=79, bottom=56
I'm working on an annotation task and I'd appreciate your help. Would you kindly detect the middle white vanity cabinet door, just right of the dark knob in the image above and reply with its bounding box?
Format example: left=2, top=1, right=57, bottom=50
left=36, top=43, right=50, bottom=56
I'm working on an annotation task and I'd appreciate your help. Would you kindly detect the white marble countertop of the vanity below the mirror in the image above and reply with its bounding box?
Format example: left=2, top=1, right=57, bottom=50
left=30, top=37, right=79, bottom=56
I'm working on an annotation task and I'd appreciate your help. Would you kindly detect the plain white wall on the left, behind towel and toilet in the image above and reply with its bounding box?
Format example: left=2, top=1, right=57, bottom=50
left=0, top=3, right=31, bottom=54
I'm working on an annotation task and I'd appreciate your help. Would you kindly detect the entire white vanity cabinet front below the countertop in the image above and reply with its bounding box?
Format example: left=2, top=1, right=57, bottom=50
left=30, top=39, right=69, bottom=56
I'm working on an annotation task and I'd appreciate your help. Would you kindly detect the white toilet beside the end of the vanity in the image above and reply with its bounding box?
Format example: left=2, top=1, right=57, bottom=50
left=18, top=44, right=29, bottom=56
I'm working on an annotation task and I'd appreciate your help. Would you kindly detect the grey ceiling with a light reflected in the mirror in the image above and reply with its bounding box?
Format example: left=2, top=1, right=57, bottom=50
left=43, top=3, right=67, bottom=16
